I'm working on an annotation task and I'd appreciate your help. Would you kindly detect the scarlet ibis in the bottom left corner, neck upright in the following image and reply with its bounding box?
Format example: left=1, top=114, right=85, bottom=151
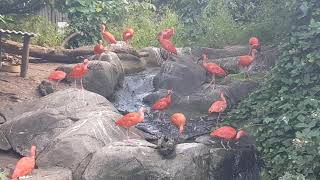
left=11, top=146, right=36, bottom=180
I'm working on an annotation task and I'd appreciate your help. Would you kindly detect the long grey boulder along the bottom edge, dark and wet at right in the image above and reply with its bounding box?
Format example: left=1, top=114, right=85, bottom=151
left=83, top=140, right=259, bottom=180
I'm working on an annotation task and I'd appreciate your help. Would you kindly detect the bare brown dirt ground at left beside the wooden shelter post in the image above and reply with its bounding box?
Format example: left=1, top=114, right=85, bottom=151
left=0, top=63, right=69, bottom=172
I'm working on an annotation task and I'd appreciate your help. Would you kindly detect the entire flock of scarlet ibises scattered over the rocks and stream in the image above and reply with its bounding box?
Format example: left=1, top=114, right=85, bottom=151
left=11, top=25, right=260, bottom=180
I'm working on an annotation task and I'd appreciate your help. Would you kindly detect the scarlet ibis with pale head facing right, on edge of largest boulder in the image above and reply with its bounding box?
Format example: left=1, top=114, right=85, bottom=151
left=116, top=107, right=147, bottom=139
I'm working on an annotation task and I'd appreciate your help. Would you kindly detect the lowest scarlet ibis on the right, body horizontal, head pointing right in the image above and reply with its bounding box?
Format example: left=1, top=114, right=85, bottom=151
left=210, top=126, right=247, bottom=149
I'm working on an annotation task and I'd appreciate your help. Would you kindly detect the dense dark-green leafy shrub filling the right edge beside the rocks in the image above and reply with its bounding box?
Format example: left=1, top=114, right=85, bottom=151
left=226, top=0, right=320, bottom=180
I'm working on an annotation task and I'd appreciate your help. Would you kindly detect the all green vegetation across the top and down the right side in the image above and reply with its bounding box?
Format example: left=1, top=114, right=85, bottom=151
left=0, top=0, right=320, bottom=180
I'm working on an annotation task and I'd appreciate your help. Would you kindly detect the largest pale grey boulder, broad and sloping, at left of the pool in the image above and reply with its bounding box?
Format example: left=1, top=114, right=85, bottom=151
left=0, top=89, right=141, bottom=177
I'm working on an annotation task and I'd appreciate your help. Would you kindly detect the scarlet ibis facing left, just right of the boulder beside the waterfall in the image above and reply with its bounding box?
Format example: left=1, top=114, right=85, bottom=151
left=202, top=54, right=227, bottom=89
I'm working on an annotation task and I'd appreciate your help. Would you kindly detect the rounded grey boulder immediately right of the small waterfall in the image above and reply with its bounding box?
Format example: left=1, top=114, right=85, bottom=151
left=153, top=56, right=206, bottom=95
